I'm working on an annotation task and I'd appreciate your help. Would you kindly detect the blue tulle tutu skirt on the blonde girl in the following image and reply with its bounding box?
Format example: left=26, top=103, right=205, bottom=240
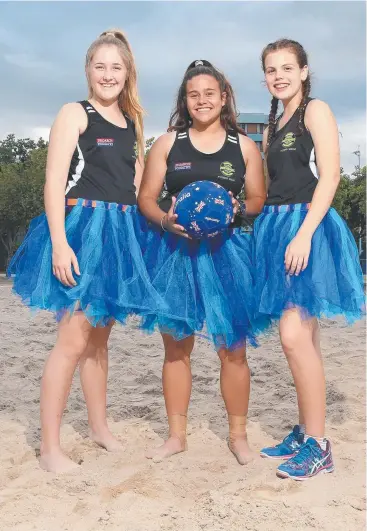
left=8, top=199, right=163, bottom=326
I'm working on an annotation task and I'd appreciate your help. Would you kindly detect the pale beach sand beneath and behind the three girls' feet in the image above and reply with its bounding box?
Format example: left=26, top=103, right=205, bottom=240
left=0, top=281, right=366, bottom=531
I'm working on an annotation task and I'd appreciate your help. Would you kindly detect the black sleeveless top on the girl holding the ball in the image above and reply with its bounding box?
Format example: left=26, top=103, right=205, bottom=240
left=159, top=129, right=246, bottom=221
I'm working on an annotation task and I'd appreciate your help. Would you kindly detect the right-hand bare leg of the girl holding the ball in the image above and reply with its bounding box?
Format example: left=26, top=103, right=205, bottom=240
left=218, top=347, right=255, bottom=465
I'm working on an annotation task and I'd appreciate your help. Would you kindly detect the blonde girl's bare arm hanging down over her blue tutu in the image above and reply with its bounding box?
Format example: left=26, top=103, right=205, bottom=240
left=44, top=103, right=87, bottom=286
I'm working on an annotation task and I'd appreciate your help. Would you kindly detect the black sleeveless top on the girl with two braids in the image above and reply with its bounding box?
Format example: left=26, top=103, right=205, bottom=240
left=266, top=98, right=318, bottom=205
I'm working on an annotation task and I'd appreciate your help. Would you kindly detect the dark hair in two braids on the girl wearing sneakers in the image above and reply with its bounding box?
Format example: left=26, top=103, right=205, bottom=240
left=261, top=39, right=311, bottom=147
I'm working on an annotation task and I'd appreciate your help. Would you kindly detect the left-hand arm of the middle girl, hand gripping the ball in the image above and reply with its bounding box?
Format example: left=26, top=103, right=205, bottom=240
left=138, top=133, right=187, bottom=237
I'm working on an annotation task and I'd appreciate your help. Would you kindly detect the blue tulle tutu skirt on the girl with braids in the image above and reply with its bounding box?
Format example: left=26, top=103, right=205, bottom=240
left=254, top=203, right=365, bottom=323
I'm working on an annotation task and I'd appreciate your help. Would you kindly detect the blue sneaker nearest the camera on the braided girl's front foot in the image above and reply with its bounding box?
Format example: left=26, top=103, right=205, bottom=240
left=277, top=437, right=334, bottom=481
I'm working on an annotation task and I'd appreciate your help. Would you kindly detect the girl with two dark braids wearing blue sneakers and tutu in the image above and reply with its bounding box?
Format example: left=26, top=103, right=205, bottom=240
left=254, top=39, right=365, bottom=480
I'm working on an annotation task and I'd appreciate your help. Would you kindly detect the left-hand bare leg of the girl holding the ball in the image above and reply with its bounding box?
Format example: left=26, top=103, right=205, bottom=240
left=146, top=334, right=195, bottom=461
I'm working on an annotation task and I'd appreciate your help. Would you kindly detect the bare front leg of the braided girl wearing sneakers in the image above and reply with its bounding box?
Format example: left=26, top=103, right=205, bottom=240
left=279, top=309, right=326, bottom=437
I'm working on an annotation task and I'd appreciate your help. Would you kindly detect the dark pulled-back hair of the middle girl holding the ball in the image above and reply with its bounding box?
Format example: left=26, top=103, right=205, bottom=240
left=168, top=59, right=246, bottom=135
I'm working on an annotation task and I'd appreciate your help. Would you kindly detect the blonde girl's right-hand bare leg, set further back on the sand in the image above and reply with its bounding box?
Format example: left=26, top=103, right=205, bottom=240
left=79, top=323, right=122, bottom=452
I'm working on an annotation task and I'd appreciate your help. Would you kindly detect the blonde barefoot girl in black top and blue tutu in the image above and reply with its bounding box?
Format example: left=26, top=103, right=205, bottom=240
left=8, top=30, right=162, bottom=472
